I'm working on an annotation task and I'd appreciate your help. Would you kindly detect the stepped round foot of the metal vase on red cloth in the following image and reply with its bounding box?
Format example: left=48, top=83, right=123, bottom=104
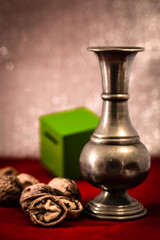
left=84, top=191, right=147, bottom=220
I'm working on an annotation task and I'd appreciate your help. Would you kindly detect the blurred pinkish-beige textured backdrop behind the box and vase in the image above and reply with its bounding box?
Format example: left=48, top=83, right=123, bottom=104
left=0, top=0, right=160, bottom=156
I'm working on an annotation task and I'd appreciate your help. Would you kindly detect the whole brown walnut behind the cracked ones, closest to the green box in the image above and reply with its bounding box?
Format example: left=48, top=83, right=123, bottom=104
left=48, top=177, right=81, bottom=201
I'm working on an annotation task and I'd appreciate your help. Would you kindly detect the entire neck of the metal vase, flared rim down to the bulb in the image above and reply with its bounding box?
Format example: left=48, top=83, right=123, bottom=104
left=89, top=47, right=143, bottom=144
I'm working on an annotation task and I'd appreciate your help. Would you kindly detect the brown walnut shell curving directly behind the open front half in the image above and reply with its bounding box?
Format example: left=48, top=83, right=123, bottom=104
left=20, top=183, right=54, bottom=214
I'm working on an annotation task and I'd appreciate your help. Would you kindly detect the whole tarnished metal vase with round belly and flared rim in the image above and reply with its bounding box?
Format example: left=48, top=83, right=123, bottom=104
left=80, top=47, right=150, bottom=220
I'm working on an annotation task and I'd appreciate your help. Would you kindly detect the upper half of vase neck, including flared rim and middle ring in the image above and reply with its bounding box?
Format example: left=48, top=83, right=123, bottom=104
left=88, top=47, right=144, bottom=100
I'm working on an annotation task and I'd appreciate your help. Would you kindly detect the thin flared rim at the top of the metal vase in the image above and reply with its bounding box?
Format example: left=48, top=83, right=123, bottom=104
left=87, top=46, right=145, bottom=52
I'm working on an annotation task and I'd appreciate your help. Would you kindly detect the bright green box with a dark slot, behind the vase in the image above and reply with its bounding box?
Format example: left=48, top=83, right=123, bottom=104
left=40, top=107, right=99, bottom=179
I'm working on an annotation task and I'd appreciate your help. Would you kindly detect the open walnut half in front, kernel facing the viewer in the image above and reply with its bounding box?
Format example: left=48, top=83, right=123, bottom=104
left=29, top=195, right=67, bottom=227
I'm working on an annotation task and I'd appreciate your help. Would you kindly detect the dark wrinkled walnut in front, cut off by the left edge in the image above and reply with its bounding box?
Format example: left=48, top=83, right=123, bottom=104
left=0, top=175, right=21, bottom=206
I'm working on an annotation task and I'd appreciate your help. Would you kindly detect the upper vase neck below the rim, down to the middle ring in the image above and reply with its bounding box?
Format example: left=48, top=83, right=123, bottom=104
left=97, top=52, right=136, bottom=99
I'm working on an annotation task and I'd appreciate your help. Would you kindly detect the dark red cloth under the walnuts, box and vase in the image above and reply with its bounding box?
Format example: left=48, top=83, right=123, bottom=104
left=0, top=159, right=160, bottom=240
